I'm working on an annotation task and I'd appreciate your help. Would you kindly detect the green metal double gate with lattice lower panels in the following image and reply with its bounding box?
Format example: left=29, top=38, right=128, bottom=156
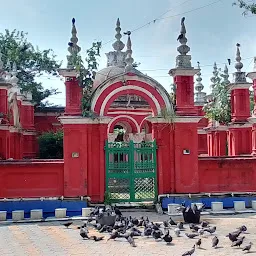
left=105, top=141, right=157, bottom=202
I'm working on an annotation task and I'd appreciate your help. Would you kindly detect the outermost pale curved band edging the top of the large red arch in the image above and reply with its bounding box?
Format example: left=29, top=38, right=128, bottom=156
left=91, top=75, right=172, bottom=114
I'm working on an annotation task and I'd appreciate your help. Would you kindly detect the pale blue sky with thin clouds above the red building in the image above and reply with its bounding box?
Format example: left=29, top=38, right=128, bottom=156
left=0, top=0, right=256, bottom=106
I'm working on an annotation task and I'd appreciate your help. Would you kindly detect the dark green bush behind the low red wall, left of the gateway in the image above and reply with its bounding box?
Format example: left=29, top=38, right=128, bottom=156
left=38, top=130, right=63, bottom=159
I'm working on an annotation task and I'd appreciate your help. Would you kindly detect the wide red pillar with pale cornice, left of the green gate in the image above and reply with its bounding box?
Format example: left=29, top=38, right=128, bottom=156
left=60, top=116, right=110, bottom=202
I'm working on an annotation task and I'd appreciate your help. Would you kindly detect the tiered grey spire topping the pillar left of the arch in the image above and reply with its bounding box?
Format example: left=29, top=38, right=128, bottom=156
left=67, top=18, right=81, bottom=69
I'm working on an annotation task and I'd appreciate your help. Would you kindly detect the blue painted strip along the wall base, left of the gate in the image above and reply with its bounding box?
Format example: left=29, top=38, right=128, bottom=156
left=0, top=200, right=87, bottom=219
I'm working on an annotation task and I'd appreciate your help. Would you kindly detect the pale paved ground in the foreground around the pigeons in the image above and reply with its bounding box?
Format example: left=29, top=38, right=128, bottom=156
left=0, top=212, right=256, bottom=256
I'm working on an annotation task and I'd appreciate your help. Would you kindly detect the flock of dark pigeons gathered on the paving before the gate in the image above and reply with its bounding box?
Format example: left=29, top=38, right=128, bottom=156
left=63, top=206, right=252, bottom=256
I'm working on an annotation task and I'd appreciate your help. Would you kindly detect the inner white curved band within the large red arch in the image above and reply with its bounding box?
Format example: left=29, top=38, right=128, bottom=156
left=99, top=85, right=161, bottom=116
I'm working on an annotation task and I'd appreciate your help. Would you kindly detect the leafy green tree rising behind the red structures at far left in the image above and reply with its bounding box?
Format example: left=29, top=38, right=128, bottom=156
left=0, top=29, right=61, bottom=106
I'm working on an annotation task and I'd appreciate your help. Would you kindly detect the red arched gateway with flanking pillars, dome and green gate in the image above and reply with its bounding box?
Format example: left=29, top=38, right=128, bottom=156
left=60, top=17, right=200, bottom=202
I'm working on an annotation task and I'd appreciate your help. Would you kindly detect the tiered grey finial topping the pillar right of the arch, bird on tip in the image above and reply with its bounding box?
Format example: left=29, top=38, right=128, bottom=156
left=176, top=17, right=191, bottom=68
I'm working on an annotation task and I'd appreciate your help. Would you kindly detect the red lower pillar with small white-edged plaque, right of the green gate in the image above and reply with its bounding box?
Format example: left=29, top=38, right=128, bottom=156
left=175, top=117, right=200, bottom=193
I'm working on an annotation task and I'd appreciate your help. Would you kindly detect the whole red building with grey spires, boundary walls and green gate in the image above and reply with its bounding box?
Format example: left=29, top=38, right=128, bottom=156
left=0, top=19, right=256, bottom=202
